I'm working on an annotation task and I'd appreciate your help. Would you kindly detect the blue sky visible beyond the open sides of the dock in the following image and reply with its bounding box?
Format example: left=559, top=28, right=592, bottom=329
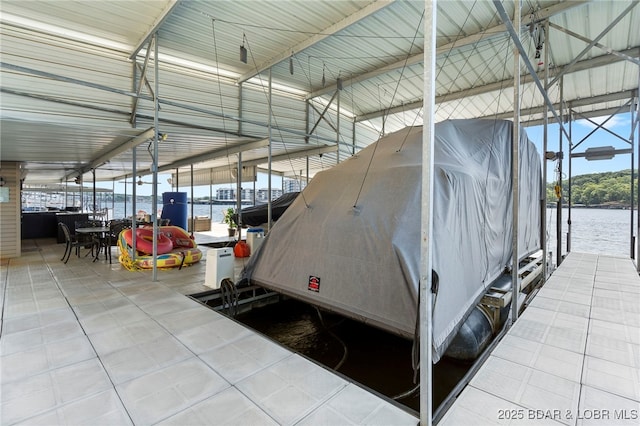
left=109, top=114, right=638, bottom=197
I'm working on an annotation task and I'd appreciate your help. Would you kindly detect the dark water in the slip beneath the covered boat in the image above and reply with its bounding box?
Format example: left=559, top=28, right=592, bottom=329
left=236, top=300, right=470, bottom=411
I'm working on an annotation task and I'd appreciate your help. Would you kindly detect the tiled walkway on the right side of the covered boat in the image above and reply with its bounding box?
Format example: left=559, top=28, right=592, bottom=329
left=439, top=253, right=640, bottom=426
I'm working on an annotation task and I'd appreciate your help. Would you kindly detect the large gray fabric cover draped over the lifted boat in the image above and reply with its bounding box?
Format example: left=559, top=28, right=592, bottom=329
left=242, top=120, right=542, bottom=362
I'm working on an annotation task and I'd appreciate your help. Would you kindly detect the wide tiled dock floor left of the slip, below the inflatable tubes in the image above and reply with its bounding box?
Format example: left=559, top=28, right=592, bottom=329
left=0, top=240, right=418, bottom=425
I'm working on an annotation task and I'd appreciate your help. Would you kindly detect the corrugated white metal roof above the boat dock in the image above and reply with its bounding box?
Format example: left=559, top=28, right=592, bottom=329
left=0, top=0, right=640, bottom=186
